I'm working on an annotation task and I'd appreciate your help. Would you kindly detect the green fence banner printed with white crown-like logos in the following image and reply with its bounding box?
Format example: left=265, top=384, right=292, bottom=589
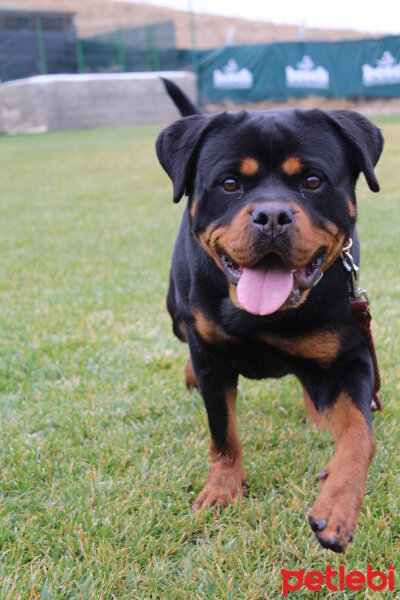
left=198, top=36, right=400, bottom=103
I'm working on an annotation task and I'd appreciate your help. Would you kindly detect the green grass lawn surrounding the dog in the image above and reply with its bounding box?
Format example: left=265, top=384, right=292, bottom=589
left=0, top=117, right=400, bottom=600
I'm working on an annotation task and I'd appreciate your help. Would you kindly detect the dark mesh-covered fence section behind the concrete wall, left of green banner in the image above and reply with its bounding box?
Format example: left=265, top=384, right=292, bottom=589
left=0, top=18, right=191, bottom=82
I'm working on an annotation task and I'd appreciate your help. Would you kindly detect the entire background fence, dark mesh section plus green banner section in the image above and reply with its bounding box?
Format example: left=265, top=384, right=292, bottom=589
left=0, top=19, right=400, bottom=104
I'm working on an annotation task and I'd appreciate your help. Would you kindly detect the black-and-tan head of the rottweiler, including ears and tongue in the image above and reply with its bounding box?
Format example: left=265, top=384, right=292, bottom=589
left=157, top=109, right=383, bottom=315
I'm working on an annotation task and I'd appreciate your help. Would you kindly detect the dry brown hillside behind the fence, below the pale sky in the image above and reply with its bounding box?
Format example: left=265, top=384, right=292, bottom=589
left=0, top=0, right=378, bottom=48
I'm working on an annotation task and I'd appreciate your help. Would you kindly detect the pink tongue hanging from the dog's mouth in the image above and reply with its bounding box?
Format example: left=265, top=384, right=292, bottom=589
left=237, top=266, right=293, bottom=315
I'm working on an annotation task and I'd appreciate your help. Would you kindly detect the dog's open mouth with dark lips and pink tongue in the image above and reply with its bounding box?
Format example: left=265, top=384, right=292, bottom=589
left=220, top=250, right=325, bottom=315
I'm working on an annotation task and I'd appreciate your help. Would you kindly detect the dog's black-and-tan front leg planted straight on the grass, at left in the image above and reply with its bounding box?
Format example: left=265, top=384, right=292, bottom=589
left=189, top=332, right=245, bottom=511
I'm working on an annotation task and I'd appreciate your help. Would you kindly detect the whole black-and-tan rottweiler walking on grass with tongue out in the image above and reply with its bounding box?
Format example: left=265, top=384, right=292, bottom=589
left=156, top=81, right=383, bottom=552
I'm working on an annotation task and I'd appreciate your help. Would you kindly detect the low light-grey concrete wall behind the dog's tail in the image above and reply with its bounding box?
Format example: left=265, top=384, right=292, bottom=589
left=0, top=71, right=197, bottom=134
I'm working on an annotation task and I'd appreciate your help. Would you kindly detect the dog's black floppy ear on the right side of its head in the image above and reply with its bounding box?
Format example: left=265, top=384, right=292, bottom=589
left=327, top=110, right=383, bottom=192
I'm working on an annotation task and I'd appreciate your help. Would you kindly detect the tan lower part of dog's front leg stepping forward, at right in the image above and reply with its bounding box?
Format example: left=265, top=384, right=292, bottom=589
left=309, top=392, right=375, bottom=552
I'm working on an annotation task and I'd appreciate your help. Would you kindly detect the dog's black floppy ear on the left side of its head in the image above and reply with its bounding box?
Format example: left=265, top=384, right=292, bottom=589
left=156, top=115, right=210, bottom=202
